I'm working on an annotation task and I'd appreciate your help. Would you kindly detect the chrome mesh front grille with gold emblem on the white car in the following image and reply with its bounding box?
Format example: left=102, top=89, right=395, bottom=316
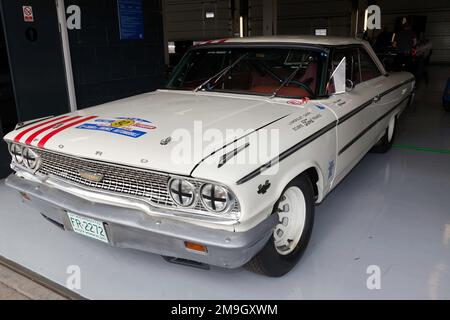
left=33, top=148, right=239, bottom=212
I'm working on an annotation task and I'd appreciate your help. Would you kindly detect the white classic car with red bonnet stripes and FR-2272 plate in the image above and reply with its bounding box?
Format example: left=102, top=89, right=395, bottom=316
left=4, top=36, right=415, bottom=276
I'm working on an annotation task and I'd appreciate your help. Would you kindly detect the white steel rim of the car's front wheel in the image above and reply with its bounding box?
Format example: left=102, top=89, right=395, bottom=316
left=273, top=187, right=306, bottom=255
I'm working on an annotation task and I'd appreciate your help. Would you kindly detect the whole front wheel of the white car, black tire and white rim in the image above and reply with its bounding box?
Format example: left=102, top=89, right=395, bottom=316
left=245, top=175, right=314, bottom=277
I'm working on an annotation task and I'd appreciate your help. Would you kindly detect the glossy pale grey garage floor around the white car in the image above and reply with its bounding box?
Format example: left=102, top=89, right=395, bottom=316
left=0, top=66, right=450, bottom=299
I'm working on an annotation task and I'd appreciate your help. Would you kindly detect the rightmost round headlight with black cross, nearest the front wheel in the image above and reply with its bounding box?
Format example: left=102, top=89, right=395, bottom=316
left=200, top=183, right=233, bottom=212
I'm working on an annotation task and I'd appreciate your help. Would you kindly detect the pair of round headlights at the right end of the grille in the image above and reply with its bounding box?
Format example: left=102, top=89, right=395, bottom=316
left=168, top=178, right=236, bottom=214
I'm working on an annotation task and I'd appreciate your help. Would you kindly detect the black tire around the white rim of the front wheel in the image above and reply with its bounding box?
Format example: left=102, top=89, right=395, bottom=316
left=244, top=175, right=315, bottom=277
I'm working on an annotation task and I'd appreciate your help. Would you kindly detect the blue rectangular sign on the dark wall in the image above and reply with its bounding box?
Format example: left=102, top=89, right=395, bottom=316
left=117, top=0, right=144, bottom=40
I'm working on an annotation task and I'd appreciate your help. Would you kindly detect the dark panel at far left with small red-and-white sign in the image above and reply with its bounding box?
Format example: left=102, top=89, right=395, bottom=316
left=0, top=0, right=70, bottom=121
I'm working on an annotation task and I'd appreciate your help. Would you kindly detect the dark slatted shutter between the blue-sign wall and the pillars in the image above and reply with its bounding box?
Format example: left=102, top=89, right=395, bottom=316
left=166, top=0, right=232, bottom=41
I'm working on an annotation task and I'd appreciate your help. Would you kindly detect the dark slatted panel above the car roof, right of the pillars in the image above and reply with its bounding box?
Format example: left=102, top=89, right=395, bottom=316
left=278, top=0, right=352, bottom=36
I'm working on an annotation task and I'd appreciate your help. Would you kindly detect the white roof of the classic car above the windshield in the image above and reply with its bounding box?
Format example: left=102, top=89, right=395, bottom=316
left=203, top=35, right=366, bottom=46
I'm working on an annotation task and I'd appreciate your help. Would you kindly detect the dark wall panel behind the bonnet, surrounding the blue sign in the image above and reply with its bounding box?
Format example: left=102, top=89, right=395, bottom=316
left=64, top=0, right=164, bottom=109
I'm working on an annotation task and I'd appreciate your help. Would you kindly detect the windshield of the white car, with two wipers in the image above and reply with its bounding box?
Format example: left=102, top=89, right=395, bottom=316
left=166, top=47, right=326, bottom=98
